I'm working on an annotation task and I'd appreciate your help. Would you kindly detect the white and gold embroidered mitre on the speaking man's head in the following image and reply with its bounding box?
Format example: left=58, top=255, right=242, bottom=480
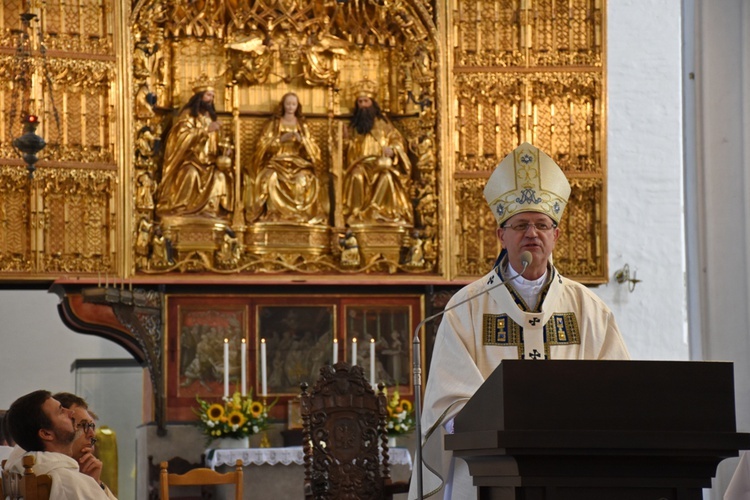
left=484, top=142, right=570, bottom=225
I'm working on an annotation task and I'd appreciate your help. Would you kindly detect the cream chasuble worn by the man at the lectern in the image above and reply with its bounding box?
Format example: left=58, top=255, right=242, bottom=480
left=409, top=266, right=629, bottom=500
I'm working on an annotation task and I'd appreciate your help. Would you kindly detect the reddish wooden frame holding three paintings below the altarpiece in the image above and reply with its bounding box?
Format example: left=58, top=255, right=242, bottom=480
left=164, top=294, right=427, bottom=421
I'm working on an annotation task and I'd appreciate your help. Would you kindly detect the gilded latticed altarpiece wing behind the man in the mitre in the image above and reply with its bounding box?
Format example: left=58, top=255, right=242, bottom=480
left=447, top=0, right=607, bottom=284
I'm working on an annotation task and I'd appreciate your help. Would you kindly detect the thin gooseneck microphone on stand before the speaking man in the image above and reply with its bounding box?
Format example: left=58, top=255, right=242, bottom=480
left=412, top=250, right=534, bottom=500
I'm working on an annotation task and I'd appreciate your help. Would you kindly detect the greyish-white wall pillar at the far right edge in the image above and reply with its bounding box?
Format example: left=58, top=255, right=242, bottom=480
left=686, top=0, right=750, bottom=500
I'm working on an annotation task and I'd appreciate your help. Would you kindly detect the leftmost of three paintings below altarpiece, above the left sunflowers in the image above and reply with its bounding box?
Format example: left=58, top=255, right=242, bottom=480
left=177, top=302, right=248, bottom=397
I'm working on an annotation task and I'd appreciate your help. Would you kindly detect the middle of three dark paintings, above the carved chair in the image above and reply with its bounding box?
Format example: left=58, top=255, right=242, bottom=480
left=256, top=304, right=336, bottom=395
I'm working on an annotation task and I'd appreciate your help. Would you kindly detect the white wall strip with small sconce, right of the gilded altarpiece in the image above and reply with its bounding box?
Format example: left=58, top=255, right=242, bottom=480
left=594, top=0, right=689, bottom=360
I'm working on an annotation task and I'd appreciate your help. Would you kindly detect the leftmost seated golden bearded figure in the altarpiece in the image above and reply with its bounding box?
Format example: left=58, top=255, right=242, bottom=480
left=156, top=81, right=233, bottom=219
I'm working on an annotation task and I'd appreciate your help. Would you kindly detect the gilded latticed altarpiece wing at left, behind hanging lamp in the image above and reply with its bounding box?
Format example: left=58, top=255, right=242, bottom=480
left=0, top=0, right=118, bottom=278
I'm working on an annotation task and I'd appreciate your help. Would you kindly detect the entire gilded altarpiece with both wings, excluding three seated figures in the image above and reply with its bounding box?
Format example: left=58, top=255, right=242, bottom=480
left=0, top=0, right=607, bottom=284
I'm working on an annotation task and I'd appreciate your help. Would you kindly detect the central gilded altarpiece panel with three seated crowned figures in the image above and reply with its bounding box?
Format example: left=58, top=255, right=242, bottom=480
left=130, top=0, right=442, bottom=275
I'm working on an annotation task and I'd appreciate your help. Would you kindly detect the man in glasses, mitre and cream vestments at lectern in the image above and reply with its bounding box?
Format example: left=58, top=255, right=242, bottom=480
left=409, top=143, right=629, bottom=499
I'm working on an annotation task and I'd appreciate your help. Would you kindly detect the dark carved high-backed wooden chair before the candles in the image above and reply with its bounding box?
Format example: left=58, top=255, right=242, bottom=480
left=300, top=363, right=409, bottom=500
